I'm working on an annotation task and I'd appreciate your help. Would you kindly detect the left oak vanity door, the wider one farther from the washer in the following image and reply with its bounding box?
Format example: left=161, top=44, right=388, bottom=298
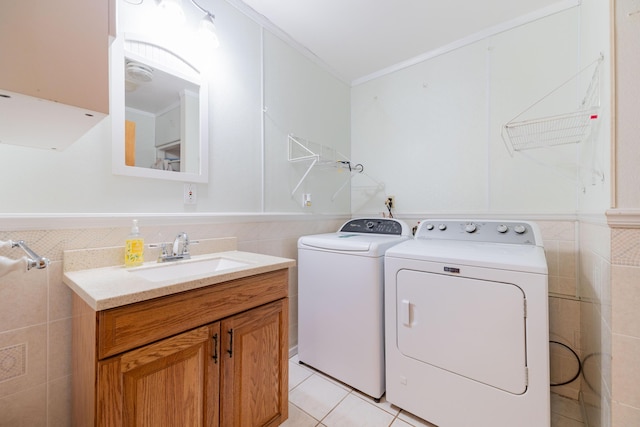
left=97, top=323, right=220, bottom=427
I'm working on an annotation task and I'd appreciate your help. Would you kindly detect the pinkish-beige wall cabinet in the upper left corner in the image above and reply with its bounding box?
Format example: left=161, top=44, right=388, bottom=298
left=0, top=0, right=115, bottom=150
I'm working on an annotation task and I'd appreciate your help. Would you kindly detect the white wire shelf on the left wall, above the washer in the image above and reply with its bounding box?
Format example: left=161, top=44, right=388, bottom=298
left=287, top=134, right=364, bottom=197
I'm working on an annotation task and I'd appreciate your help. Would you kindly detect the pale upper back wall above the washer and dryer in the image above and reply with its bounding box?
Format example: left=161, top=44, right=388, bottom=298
left=351, top=8, right=584, bottom=214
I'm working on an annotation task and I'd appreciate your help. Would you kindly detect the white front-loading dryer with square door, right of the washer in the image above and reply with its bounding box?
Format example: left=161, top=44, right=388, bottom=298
left=385, top=219, right=550, bottom=427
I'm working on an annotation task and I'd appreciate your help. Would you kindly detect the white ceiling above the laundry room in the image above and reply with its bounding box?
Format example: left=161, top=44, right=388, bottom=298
left=231, top=0, right=580, bottom=84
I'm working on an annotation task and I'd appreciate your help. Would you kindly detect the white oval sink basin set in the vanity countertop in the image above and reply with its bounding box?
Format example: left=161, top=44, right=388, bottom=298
left=128, top=257, right=249, bottom=282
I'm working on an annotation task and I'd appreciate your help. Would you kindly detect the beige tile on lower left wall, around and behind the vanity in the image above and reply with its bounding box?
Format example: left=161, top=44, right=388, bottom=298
left=0, top=218, right=346, bottom=427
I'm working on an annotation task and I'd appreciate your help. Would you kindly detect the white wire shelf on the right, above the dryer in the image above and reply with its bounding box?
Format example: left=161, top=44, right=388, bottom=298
left=502, top=55, right=603, bottom=156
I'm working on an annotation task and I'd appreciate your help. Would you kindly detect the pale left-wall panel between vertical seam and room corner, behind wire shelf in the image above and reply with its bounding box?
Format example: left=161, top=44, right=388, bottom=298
left=264, top=32, right=351, bottom=213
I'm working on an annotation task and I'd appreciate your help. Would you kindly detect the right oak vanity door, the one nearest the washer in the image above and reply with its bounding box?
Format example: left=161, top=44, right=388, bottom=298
left=220, top=298, right=288, bottom=427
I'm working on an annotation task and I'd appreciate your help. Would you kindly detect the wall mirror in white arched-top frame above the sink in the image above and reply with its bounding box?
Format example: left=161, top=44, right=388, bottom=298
left=110, top=34, right=208, bottom=182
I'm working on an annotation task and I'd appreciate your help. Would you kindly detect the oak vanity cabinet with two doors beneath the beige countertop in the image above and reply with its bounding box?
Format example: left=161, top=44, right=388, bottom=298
left=73, top=269, right=288, bottom=427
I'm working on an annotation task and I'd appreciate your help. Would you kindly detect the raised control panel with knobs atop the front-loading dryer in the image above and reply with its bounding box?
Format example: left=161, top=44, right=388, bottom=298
left=415, top=219, right=541, bottom=245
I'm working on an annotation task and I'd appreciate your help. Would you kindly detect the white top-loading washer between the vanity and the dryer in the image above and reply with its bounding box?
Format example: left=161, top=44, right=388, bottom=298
left=298, top=218, right=411, bottom=400
